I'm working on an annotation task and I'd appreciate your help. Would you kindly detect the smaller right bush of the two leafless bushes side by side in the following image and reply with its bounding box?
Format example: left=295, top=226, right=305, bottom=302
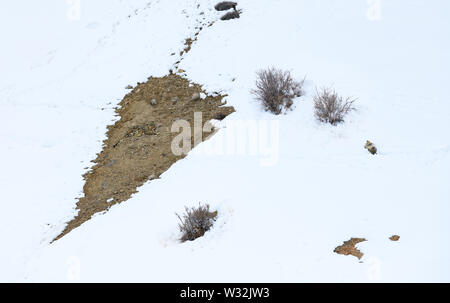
left=314, top=88, right=356, bottom=125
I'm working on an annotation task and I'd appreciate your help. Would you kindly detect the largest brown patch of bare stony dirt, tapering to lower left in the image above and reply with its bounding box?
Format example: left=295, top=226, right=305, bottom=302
left=53, top=74, right=234, bottom=241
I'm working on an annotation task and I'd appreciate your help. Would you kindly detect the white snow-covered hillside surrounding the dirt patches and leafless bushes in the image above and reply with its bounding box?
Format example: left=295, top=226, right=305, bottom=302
left=0, top=0, right=450, bottom=282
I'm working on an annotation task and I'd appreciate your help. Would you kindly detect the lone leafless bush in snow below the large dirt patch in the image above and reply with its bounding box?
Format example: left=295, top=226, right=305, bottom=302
left=176, top=204, right=217, bottom=242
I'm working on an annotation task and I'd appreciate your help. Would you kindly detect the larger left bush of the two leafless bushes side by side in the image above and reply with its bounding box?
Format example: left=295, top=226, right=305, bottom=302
left=252, top=68, right=304, bottom=115
